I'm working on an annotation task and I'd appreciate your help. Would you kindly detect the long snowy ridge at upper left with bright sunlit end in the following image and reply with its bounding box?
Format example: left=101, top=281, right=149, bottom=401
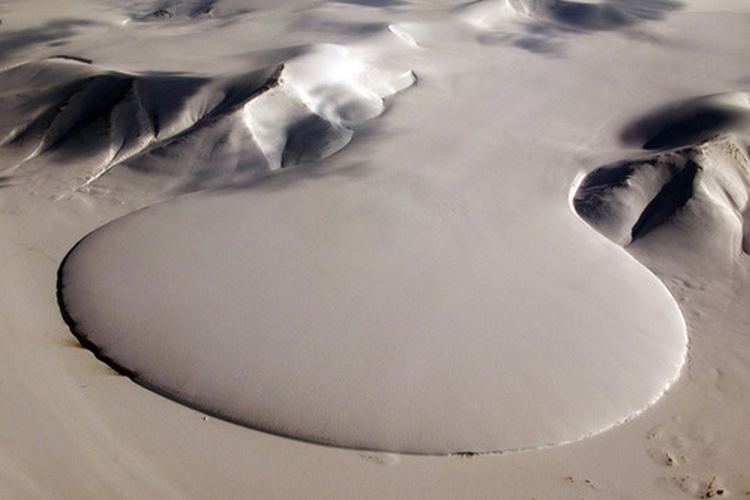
left=0, top=44, right=415, bottom=191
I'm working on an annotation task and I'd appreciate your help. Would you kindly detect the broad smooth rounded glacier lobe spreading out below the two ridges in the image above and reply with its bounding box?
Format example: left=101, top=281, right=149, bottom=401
left=59, top=171, right=687, bottom=454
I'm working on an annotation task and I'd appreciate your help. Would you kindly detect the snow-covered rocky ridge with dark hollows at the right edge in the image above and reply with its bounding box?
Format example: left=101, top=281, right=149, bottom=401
left=574, top=93, right=750, bottom=253
